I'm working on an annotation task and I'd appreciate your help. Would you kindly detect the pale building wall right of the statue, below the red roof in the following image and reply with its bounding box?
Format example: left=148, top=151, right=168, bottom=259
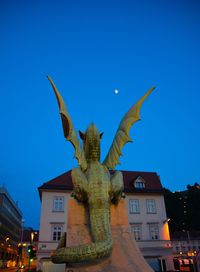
left=126, top=193, right=173, bottom=271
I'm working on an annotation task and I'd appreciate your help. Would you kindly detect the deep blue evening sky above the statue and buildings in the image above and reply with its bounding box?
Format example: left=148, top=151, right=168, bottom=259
left=0, top=0, right=200, bottom=228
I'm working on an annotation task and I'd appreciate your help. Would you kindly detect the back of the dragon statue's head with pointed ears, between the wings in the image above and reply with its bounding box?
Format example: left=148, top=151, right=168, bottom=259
left=79, top=123, right=103, bottom=162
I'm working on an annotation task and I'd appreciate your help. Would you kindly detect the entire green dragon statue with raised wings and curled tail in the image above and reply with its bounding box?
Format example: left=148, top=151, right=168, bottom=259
left=48, top=77, right=154, bottom=263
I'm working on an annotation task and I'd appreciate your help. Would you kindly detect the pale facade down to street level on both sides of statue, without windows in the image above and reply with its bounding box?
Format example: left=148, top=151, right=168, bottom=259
left=38, top=191, right=171, bottom=268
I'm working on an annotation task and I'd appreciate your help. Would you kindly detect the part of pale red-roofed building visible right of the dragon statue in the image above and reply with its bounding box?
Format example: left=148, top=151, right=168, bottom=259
left=123, top=171, right=173, bottom=271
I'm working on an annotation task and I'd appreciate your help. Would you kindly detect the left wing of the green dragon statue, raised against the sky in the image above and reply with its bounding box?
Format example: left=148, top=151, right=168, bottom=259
left=47, top=76, right=87, bottom=171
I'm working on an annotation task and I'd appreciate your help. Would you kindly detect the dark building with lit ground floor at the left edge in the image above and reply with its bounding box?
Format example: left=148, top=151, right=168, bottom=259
left=0, top=187, right=22, bottom=268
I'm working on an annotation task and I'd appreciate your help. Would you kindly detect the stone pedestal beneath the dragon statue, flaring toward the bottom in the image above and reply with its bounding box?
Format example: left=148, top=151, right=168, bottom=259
left=66, top=200, right=153, bottom=272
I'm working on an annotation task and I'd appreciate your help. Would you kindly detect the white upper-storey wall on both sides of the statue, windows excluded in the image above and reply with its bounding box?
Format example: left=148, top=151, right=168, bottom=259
left=39, top=191, right=170, bottom=244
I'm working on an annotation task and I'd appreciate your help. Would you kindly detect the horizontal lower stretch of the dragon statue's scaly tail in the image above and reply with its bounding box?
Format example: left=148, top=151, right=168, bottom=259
left=51, top=239, right=112, bottom=264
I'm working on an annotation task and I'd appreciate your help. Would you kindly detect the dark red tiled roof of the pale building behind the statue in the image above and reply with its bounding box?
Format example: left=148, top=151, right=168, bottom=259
left=38, top=170, right=163, bottom=197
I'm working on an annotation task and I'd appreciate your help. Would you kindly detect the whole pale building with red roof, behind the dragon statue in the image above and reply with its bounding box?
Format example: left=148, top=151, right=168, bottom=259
left=38, top=171, right=173, bottom=271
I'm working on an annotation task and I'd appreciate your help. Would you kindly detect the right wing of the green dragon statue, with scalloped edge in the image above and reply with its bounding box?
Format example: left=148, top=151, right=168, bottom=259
left=103, top=87, right=155, bottom=170
